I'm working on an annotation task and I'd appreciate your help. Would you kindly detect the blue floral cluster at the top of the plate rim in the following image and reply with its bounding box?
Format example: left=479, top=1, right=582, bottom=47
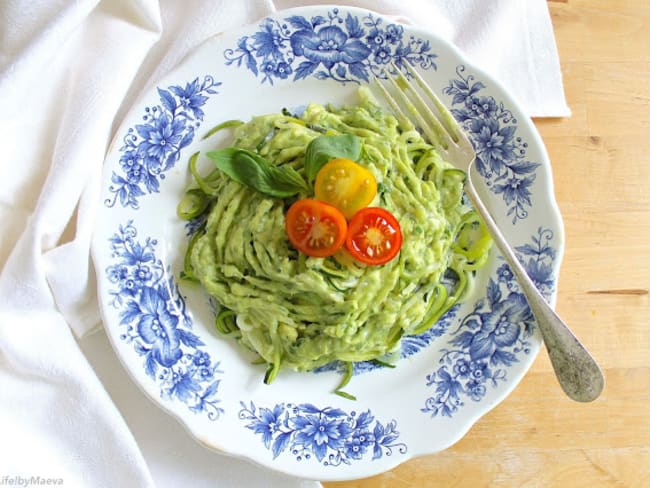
left=224, top=8, right=437, bottom=84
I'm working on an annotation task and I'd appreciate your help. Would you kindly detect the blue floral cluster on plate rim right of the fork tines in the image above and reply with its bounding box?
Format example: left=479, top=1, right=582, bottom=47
left=443, top=65, right=540, bottom=224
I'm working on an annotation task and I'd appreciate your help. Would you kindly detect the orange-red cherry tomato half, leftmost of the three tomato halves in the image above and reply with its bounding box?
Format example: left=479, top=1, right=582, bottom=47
left=284, top=198, right=348, bottom=258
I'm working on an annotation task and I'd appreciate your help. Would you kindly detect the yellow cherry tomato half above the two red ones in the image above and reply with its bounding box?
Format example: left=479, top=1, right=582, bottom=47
left=314, top=158, right=377, bottom=219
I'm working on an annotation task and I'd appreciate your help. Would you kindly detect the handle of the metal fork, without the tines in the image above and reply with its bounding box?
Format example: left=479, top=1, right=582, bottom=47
left=465, top=181, right=605, bottom=402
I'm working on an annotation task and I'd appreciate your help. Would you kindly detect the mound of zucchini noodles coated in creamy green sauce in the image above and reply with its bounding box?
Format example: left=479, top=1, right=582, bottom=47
left=182, top=88, right=489, bottom=382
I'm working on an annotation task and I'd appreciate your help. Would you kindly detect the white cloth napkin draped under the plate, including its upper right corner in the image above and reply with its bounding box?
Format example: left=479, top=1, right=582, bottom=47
left=0, top=0, right=569, bottom=487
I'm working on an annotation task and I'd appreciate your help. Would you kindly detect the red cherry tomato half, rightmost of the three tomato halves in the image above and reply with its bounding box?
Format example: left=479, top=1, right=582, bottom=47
left=345, top=207, right=402, bottom=265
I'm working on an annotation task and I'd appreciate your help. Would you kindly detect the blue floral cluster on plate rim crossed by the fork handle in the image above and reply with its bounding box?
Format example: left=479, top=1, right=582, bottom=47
left=421, top=228, right=556, bottom=417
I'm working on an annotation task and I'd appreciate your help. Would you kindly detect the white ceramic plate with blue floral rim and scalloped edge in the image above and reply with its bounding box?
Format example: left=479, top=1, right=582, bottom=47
left=93, top=7, right=563, bottom=480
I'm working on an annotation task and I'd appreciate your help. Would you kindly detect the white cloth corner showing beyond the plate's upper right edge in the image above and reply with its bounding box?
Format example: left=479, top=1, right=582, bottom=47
left=274, top=0, right=571, bottom=117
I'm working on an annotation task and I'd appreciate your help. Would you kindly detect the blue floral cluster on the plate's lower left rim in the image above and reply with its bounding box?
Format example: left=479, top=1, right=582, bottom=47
left=106, top=221, right=223, bottom=420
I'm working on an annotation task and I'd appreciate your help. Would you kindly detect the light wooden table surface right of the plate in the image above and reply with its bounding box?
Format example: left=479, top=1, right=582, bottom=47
left=324, top=0, right=650, bottom=488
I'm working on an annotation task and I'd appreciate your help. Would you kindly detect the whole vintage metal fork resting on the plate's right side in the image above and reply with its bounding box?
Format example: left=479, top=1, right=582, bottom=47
left=373, top=63, right=605, bottom=402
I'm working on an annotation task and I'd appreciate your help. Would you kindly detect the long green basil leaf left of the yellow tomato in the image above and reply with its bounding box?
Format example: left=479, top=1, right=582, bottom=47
left=207, top=147, right=307, bottom=198
